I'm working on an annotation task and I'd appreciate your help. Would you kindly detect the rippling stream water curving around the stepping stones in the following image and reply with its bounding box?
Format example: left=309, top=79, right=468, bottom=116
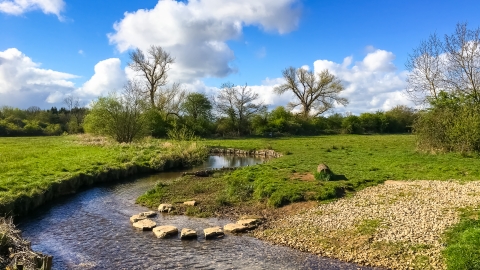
left=19, top=156, right=376, bottom=269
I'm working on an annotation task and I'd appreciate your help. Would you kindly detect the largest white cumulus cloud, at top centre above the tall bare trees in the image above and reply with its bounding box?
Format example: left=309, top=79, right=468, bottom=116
left=108, top=0, right=300, bottom=82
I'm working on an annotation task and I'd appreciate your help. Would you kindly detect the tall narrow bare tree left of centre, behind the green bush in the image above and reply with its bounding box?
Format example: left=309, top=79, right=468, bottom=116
left=128, top=45, right=175, bottom=108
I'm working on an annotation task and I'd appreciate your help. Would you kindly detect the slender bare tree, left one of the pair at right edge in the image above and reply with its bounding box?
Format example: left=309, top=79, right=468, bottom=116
left=405, top=34, right=446, bottom=105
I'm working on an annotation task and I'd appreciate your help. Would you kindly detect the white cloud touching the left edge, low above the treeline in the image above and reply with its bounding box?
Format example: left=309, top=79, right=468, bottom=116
left=0, top=48, right=77, bottom=108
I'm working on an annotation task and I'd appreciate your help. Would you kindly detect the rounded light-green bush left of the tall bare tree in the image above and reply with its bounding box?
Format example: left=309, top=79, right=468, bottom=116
left=85, top=81, right=148, bottom=143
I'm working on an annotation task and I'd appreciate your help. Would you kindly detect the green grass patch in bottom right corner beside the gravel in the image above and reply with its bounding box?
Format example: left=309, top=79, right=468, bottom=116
left=443, top=209, right=480, bottom=270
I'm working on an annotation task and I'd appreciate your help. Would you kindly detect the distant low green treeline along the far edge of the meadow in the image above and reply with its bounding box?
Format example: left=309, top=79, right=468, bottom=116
left=0, top=103, right=417, bottom=137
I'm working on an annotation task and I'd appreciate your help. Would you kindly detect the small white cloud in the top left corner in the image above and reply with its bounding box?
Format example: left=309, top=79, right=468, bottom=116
left=0, top=0, right=65, bottom=19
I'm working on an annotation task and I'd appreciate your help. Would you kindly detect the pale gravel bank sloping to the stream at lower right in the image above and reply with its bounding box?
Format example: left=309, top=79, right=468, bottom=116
left=255, top=181, right=480, bottom=269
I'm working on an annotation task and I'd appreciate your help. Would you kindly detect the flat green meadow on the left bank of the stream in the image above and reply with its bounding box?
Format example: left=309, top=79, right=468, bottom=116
left=0, top=136, right=208, bottom=214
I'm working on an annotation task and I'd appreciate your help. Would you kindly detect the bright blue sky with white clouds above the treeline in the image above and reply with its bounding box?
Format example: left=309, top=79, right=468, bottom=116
left=0, top=0, right=480, bottom=114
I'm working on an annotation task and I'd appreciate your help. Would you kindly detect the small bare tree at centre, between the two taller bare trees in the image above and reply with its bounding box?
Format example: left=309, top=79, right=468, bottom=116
left=216, top=82, right=266, bottom=134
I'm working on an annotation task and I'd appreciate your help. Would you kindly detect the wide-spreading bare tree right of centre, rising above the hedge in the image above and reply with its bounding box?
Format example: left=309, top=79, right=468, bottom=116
left=274, top=67, right=348, bottom=118
